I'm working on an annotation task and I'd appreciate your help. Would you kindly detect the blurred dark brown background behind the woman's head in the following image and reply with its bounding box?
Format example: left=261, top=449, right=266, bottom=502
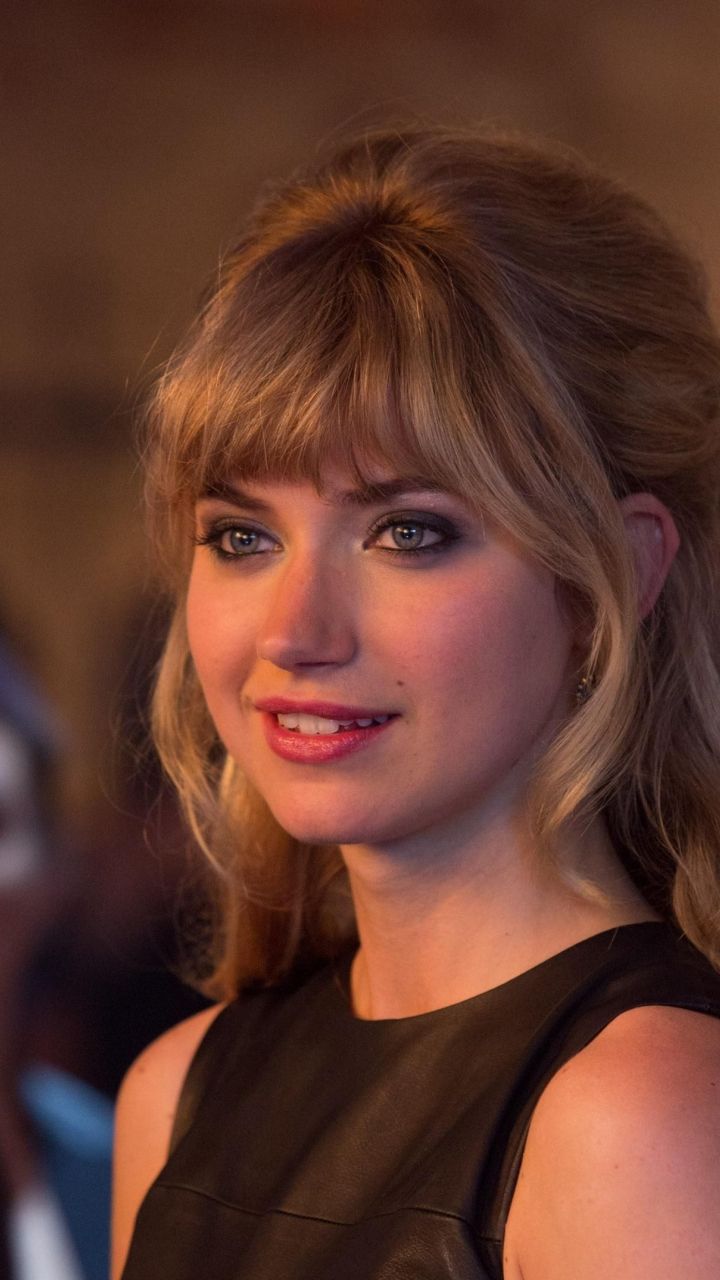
left=0, top=0, right=720, bottom=1269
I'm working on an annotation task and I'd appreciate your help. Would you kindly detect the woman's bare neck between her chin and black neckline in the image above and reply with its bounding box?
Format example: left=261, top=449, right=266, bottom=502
left=343, top=820, right=657, bottom=1019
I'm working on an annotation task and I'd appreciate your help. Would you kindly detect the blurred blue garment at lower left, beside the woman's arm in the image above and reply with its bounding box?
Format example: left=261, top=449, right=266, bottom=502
left=20, top=1065, right=114, bottom=1280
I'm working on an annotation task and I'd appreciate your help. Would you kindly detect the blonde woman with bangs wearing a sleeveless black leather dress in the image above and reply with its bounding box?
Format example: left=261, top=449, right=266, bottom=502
left=110, top=122, right=720, bottom=1280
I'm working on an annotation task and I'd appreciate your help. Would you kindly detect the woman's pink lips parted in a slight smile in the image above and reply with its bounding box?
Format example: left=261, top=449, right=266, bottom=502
left=255, top=698, right=397, bottom=764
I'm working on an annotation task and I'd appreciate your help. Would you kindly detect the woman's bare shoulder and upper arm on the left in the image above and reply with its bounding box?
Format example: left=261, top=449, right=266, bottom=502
left=111, top=1005, right=223, bottom=1280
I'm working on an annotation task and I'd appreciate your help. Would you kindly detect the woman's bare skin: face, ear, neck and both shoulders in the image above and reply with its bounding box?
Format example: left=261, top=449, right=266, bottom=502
left=114, top=472, right=720, bottom=1280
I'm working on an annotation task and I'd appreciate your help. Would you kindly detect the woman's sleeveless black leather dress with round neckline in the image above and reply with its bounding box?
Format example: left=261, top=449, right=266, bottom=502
left=123, top=923, right=720, bottom=1280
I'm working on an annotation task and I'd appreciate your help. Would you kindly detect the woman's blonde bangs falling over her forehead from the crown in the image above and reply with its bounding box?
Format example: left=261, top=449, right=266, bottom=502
left=154, top=207, right=538, bottom=552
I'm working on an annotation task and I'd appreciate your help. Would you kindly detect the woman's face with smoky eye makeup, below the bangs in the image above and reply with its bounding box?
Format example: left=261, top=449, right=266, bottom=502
left=187, top=472, right=577, bottom=845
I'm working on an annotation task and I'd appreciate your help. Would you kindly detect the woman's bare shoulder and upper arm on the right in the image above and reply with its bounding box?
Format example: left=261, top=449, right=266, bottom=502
left=505, top=1006, right=720, bottom=1280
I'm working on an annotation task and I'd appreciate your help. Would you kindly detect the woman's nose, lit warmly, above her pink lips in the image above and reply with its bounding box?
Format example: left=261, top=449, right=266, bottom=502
left=256, top=557, right=357, bottom=671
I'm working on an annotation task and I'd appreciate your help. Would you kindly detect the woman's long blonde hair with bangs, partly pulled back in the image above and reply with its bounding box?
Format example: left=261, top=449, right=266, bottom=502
left=142, top=128, right=720, bottom=996
